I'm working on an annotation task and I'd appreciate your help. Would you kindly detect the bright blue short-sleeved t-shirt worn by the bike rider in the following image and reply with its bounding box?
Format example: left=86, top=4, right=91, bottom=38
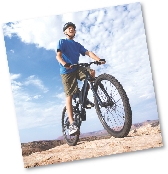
left=57, top=39, right=87, bottom=74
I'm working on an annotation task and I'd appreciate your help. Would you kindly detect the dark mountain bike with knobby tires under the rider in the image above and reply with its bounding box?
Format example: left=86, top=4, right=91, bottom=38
left=62, top=61, right=132, bottom=146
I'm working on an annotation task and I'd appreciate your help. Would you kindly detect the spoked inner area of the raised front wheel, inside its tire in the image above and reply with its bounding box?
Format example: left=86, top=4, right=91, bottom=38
left=94, top=80, right=125, bottom=131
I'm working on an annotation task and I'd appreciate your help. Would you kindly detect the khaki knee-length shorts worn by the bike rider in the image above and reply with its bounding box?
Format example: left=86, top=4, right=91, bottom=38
left=61, top=67, right=92, bottom=97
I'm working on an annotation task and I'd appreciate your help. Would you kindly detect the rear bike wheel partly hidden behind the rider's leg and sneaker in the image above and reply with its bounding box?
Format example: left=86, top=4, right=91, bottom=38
left=62, top=107, right=79, bottom=146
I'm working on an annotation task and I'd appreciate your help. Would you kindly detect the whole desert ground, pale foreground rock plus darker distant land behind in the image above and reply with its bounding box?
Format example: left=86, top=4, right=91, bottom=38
left=21, top=120, right=163, bottom=168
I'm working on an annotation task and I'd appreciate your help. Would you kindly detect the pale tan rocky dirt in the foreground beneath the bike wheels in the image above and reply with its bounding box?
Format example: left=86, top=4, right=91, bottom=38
left=23, top=124, right=163, bottom=168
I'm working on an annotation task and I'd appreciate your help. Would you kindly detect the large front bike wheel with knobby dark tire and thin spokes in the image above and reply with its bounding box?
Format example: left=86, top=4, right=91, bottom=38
left=94, top=74, right=132, bottom=138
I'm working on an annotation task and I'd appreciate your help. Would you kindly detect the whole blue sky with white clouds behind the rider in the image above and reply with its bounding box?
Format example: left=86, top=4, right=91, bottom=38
left=3, top=3, right=158, bottom=142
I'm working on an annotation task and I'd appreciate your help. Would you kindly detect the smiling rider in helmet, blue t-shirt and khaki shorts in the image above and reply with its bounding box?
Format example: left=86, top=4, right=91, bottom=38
left=56, top=22, right=105, bottom=135
